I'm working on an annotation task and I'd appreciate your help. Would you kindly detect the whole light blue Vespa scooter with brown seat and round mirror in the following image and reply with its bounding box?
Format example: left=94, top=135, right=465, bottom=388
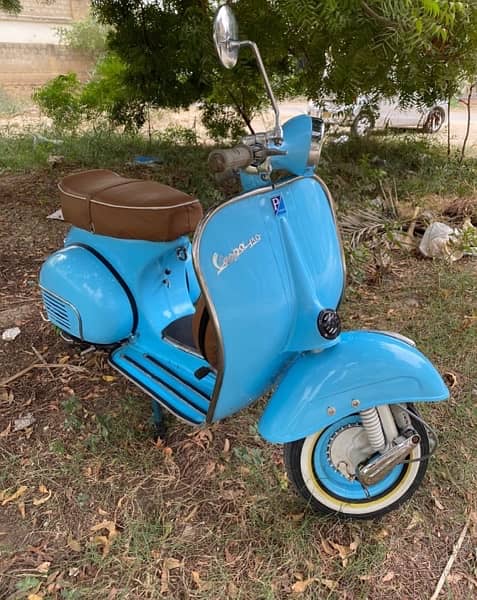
left=40, top=6, right=448, bottom=518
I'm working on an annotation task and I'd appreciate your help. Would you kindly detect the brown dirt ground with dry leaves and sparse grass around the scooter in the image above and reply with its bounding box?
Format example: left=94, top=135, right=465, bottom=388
left=0, top=157, right=477, bottom=600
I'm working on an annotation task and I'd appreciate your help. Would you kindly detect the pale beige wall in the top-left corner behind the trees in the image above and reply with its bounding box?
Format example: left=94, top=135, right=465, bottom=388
left=0, top=0, right=91, bottom=96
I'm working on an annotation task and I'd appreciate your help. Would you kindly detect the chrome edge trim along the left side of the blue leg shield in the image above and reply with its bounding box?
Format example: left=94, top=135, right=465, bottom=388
left=192, top=185, right=274, bottom=423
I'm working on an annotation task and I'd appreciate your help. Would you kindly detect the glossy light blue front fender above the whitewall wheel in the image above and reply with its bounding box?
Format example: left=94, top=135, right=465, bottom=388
left=258, top=331, right=449, bottom=443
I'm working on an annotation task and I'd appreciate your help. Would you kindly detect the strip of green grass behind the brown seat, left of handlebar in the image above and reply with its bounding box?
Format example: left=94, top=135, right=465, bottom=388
left=0, top=127, right=224, bottom=207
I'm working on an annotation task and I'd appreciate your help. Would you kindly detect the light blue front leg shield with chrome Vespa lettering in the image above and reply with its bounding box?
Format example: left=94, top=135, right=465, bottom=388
left=194, top=177, right=344, bottom=421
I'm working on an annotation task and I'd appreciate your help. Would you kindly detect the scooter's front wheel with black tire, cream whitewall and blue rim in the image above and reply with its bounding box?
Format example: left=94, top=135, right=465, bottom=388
left=284, top=406, right=429, bottom=519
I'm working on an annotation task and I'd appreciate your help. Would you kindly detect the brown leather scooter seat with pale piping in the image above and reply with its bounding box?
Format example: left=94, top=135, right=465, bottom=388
left=58, top=169, right=202, bottom=242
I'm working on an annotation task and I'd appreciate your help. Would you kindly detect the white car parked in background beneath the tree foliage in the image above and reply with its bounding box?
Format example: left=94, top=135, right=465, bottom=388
left=307, top=96, right=447, bottom=136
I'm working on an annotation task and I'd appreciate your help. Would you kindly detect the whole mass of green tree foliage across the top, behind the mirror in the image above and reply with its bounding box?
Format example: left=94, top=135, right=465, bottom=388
left=87, top=0, right=477, bottom=139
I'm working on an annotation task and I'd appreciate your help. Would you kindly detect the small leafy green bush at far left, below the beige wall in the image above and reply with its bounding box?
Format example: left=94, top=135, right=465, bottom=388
left=33, top=73, right=82, bottom=131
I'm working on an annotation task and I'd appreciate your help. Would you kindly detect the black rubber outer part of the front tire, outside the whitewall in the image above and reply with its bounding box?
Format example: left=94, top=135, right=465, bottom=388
left=283, top=404, right=429, bottom=520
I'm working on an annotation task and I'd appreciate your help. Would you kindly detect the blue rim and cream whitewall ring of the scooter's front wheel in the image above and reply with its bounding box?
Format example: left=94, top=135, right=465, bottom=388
left=301, top=415, right=421, bottom=515
